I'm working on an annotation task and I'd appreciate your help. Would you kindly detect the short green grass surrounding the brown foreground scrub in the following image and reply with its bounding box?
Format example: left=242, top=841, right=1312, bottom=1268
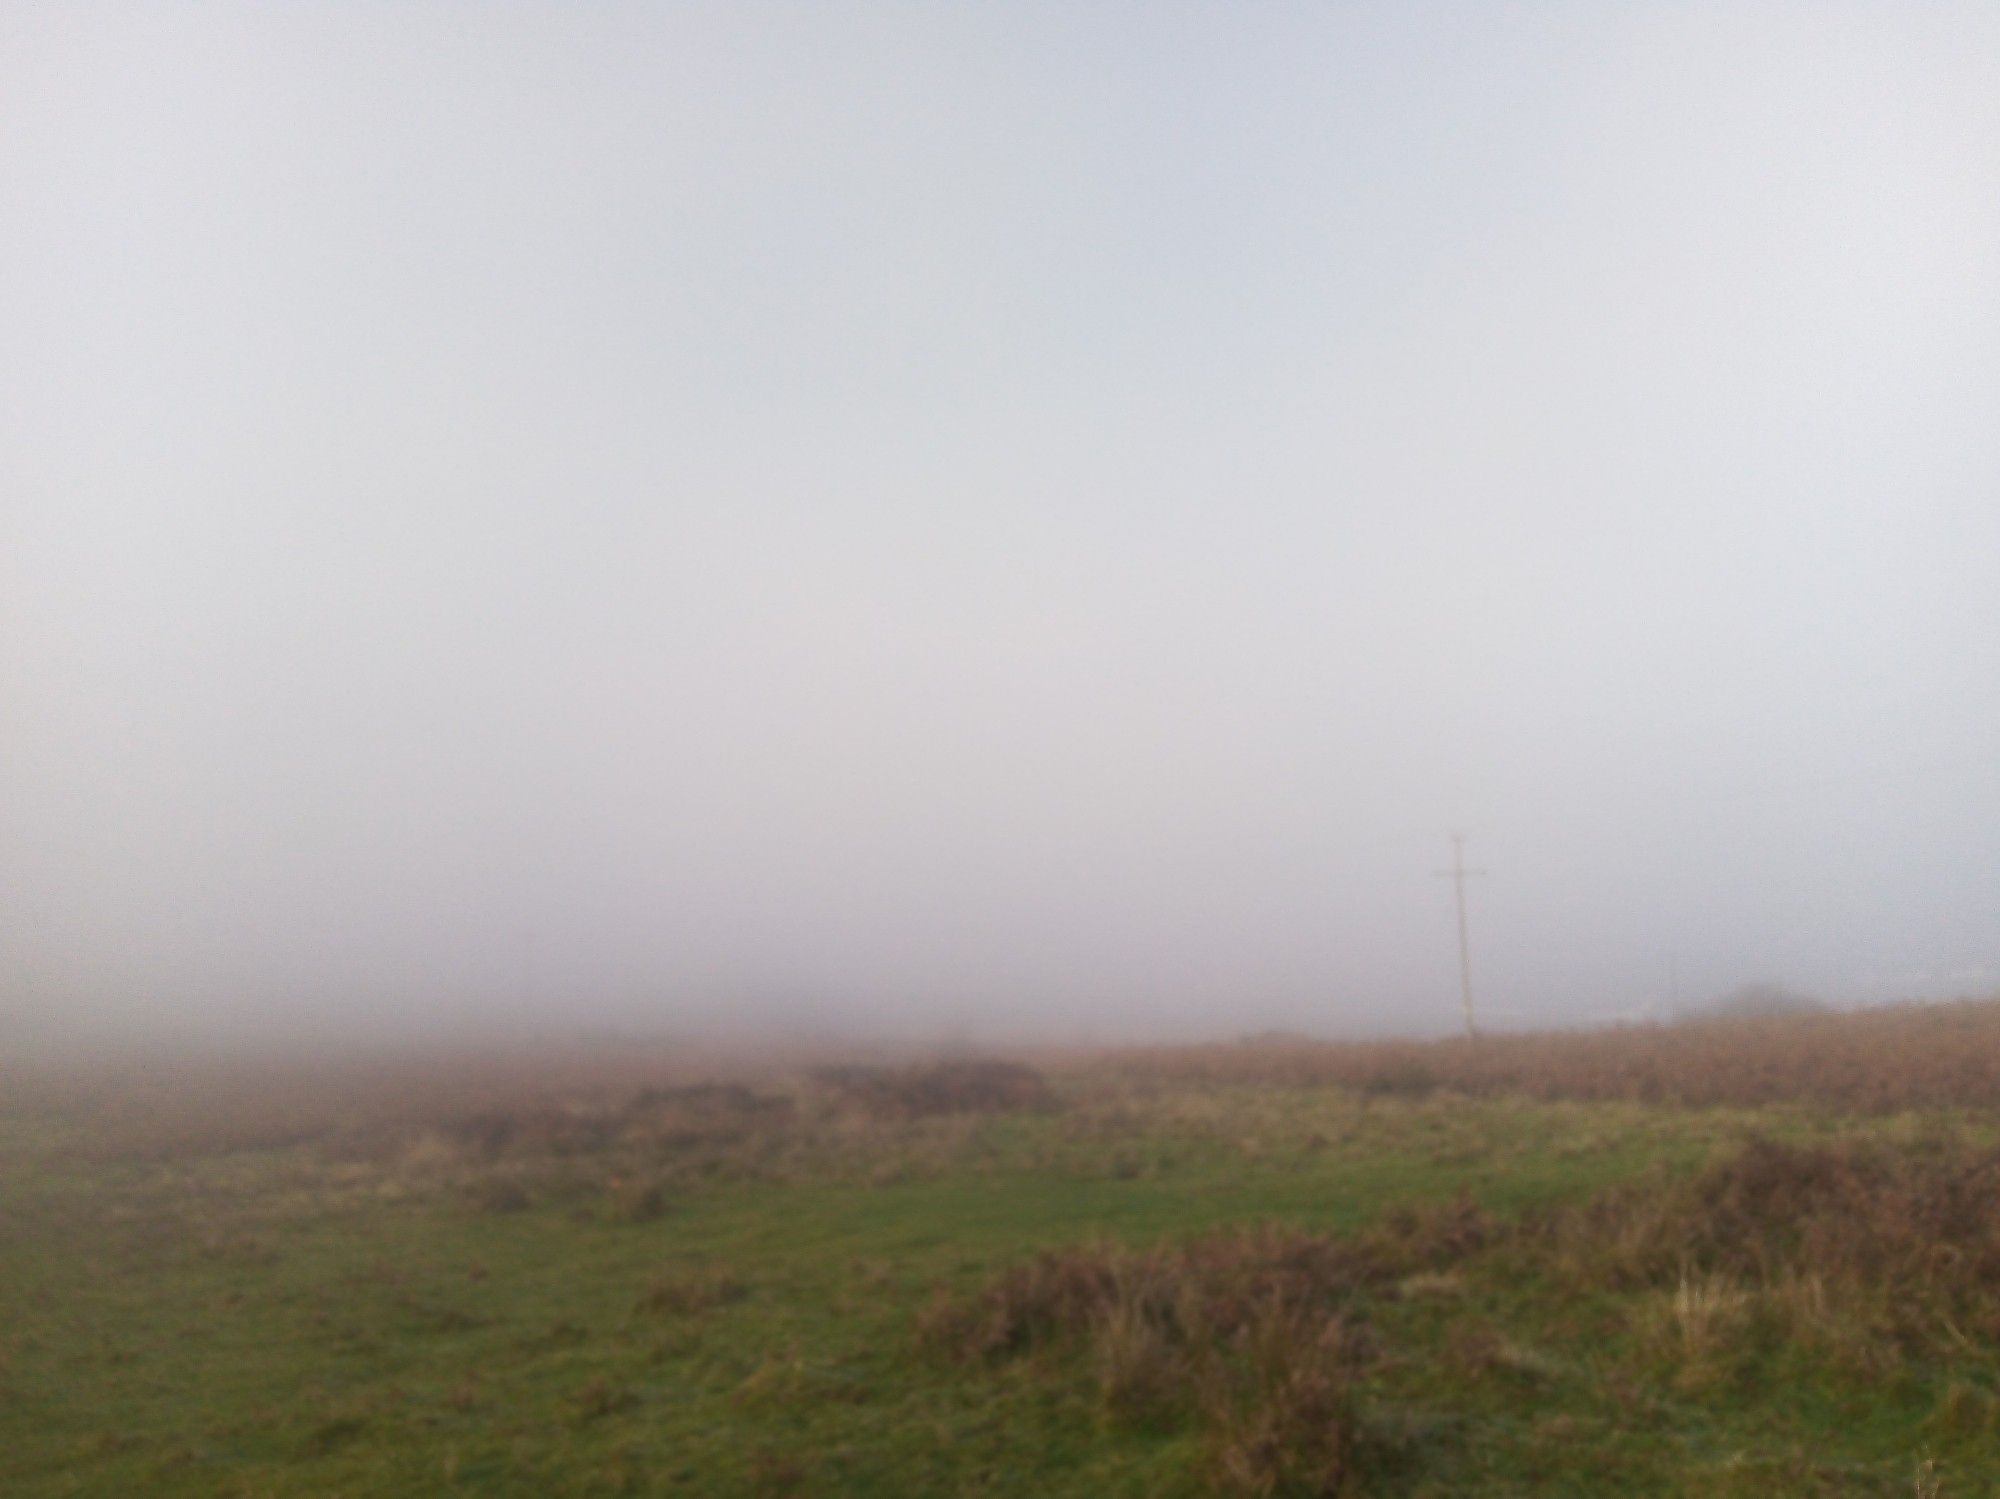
left=0, top=1087, right=2000, bottom=1497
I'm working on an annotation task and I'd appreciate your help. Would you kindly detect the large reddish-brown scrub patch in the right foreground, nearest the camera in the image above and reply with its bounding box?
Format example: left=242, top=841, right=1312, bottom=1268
left=920, top=1141, right=2000, bottom=1493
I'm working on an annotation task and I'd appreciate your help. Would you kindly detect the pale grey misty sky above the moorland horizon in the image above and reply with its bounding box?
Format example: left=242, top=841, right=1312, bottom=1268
left=0, top=0, right=2000, bottom=1039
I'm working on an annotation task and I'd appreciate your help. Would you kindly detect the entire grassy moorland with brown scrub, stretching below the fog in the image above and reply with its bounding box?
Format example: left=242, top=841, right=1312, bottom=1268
left=11, top=1011, right=2000, bottom=1495
